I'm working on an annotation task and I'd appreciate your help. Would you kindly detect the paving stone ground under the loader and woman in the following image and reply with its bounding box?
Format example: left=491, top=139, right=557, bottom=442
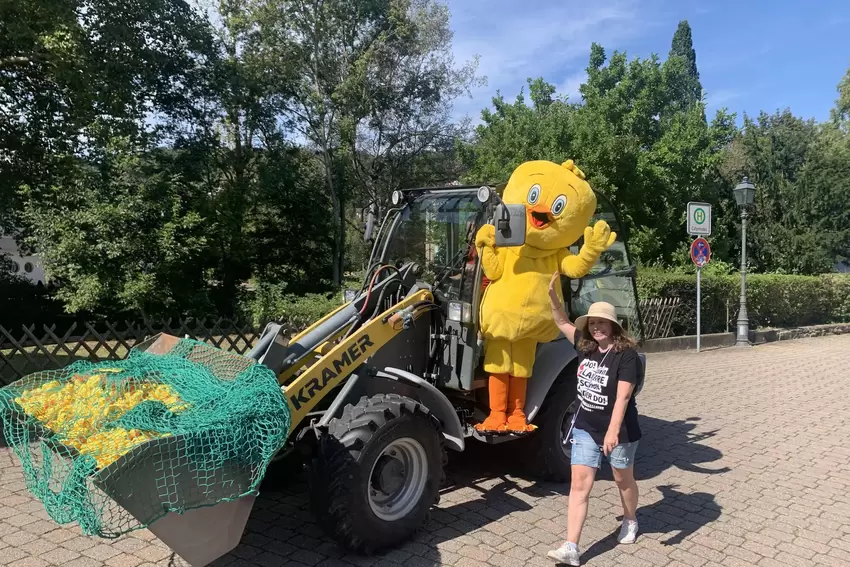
left=0, top=335, right=850, bottom=567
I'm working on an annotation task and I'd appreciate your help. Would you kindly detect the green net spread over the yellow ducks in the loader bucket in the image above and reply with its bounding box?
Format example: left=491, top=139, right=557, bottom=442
left=0, top=339, right=290, bottom=538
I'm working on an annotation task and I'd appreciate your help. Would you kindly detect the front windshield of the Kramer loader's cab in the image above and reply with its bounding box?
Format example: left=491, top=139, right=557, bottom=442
left=385, top=191, right=485, bottom=301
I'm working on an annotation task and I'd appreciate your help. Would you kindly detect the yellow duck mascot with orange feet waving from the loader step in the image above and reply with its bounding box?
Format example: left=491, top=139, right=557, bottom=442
left=475, top=160, right=617, bottom=432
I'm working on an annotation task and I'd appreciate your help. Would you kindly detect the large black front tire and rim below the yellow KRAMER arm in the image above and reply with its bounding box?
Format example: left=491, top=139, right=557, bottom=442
left=310, top=394, right=446, bottom=554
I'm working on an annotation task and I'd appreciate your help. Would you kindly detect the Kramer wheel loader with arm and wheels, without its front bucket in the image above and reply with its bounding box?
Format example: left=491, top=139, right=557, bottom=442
left=242, top=185, right=645, bottom=553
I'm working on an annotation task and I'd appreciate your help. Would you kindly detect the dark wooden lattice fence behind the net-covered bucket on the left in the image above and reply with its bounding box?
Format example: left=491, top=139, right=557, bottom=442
left=0, top=319, right=309, bottom=385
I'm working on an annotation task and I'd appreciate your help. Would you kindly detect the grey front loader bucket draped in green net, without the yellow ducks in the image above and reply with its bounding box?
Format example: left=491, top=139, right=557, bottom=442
left=0, top=334, right=289, bottom=567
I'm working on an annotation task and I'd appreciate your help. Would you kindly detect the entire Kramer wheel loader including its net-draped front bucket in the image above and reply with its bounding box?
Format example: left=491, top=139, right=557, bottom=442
left=0, top=181, right=646, bottom=567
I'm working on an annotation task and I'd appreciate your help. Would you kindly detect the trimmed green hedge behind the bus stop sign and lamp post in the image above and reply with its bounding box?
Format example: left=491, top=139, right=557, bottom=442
left=637, top=271, right=850, bottom=335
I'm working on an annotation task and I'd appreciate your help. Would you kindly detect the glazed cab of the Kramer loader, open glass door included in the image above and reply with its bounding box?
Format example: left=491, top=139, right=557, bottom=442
left=370, top=185, right=643, bottom=392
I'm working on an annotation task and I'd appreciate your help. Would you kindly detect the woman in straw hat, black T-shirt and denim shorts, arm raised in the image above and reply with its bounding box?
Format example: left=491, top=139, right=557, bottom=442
left=549, top=273, right=641, bottom=565
